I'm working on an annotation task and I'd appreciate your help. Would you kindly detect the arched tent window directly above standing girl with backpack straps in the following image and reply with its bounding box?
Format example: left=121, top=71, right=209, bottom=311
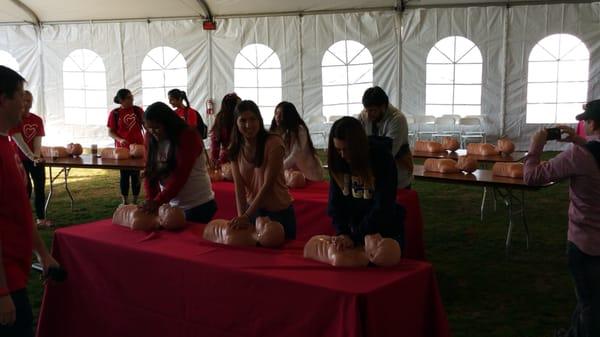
left=142, top=47, right=187, bottom=108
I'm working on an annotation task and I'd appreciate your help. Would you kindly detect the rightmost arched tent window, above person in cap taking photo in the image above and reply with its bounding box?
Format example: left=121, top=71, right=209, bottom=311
left=526, top=34, right=590, bottom=124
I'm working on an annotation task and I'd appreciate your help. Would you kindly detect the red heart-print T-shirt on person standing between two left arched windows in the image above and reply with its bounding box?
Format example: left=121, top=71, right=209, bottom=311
left=106, top=105, right=144, bottom=148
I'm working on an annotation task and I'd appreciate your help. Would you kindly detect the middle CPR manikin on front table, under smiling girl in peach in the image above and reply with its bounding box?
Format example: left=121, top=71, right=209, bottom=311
left=202, top=217, right=285, bottom=248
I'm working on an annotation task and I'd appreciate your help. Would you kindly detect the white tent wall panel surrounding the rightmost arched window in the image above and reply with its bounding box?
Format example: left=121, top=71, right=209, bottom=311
left=505, top=2, right=600, bottom=149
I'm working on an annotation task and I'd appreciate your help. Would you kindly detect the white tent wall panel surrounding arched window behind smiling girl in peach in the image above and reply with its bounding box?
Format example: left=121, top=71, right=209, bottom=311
left=211, top=16, right=302, bottom=124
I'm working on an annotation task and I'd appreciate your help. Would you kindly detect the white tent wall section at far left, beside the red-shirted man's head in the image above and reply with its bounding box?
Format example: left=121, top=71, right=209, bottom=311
left=0, top=25, right=44, bottom=117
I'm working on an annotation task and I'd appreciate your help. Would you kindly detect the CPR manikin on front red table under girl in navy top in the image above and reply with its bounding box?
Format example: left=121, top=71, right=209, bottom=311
left=304, top=234, right=402, bottom=267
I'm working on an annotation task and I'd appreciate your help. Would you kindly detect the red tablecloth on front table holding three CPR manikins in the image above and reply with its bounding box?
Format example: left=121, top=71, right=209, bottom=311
left=38, top=220, right=450, bottom=337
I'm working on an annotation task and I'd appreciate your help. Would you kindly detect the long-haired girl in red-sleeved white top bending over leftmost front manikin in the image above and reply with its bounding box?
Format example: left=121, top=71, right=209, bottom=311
left=140, top=102, right=217, bottom=223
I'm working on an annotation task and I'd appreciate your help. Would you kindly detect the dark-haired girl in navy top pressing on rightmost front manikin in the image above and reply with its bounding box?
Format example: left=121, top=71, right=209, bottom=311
left=327, top=117, right=405, bottom=248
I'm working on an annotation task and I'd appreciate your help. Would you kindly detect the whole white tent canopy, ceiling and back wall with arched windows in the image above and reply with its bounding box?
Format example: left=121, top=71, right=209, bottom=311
left=0, top=0, right=600, bottom=148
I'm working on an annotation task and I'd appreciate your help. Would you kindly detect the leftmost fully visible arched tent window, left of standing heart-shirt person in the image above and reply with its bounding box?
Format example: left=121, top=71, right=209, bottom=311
left=63, top=49, right=108, bottom=125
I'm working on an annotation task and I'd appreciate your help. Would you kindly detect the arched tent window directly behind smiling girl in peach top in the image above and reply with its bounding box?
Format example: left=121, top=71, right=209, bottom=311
left=234, top=43, right=281, bottom=124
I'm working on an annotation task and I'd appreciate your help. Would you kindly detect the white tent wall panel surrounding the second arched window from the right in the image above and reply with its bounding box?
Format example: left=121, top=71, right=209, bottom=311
left=402, top=7, right=505, bottom=135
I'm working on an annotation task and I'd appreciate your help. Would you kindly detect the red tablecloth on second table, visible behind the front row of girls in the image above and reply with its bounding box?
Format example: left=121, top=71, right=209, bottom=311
left=213, top=181, right=425, bottom=260
